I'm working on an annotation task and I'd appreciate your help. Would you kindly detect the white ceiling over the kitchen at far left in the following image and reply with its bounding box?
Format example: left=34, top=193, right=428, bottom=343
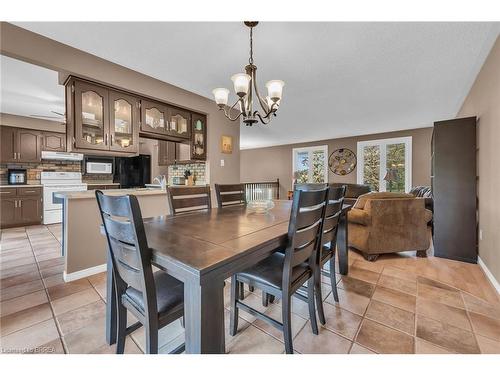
left=0, top=55, right=64, bottom=123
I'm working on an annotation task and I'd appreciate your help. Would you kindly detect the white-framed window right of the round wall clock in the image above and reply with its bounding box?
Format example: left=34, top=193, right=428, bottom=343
left=357, top=137, right=411, bottom=193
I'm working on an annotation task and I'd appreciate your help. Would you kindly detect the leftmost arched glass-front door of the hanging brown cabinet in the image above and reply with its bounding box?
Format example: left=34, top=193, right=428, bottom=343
left=75, top=81, right=109, bottom=150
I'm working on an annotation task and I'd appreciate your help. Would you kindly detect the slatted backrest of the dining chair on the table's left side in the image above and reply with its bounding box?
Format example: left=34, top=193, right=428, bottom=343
left=95, top=190, right=157, bottom=316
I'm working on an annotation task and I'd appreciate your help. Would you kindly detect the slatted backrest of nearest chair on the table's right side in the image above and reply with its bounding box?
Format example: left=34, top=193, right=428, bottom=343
left=283, top=188, right=328, bottom=288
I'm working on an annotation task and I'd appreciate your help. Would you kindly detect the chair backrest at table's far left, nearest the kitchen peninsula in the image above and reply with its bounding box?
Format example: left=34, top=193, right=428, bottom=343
left=168, top=185, right=212, bottom=215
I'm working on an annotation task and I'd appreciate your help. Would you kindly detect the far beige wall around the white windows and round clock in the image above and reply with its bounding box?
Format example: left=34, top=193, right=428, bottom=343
left=241, top=128, right=432, bottom=197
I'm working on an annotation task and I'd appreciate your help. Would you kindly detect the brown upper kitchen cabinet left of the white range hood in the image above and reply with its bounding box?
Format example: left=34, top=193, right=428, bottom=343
left=1, top=126, right=42, bottom=163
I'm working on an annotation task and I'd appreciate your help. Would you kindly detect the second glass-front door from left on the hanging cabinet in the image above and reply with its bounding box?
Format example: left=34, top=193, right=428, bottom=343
left=109, top=91, right=139, bottom=152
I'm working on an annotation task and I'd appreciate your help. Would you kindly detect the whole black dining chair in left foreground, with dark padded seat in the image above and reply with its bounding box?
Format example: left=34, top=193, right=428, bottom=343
left=95, top=190, right=184, bottom=354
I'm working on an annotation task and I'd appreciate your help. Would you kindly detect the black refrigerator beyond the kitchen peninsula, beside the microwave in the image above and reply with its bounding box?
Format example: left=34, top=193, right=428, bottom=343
left=113, top=155, right=151, bottom=189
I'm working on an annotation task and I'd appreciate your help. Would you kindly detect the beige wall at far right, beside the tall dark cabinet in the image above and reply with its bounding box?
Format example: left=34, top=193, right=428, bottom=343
left=457, top=37, right=500, bottom=282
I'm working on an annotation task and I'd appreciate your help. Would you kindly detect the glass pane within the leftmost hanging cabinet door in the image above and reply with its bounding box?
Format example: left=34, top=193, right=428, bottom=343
left=82, top=91, right=104, bottom=145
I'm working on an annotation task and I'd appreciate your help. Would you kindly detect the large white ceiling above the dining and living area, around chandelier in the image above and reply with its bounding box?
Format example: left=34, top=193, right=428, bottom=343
left=6, top=22, right=500, bottom=148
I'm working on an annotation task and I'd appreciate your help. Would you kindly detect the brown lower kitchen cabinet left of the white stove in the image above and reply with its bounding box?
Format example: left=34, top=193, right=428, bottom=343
left=0, top=186, right=43, bottom=228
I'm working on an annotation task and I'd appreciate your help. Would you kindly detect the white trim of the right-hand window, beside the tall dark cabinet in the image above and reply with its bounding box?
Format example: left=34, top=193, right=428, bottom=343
left=356, top=136, right=413, bottom=193
